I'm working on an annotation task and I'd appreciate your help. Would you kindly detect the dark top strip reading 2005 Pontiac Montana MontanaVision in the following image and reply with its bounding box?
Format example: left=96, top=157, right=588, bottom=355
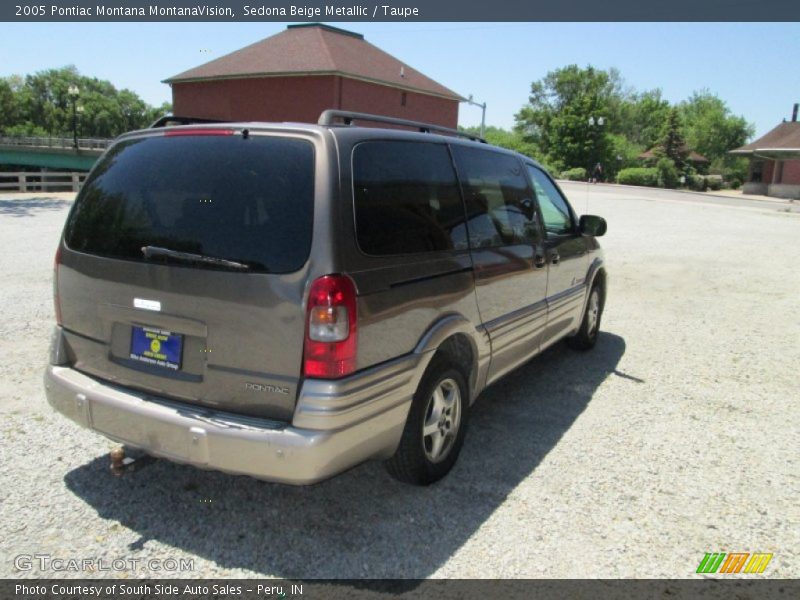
left=0, top=0, right=800, bottom=22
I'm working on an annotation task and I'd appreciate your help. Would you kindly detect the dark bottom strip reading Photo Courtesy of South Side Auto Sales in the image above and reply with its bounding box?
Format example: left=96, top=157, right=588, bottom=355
left=6, top=576, right=800, bottom=600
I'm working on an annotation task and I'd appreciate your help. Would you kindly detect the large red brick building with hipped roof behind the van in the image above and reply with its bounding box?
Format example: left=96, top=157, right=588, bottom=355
left=164, top=23, right=464, bottom=128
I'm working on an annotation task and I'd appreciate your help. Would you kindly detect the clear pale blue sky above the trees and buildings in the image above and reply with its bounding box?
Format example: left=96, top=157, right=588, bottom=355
left=0, top=22, right=800, bottom=135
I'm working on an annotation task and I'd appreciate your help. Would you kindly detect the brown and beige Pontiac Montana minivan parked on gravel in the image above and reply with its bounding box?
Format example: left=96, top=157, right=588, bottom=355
left=45, top=111, right=606, bottom=485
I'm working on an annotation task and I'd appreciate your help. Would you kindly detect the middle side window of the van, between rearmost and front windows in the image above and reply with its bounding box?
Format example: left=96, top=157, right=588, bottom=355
left=453, top=146, right=541, bottom=248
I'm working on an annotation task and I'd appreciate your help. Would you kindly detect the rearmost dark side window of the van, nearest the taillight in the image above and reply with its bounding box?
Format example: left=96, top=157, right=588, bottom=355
left=353, top=141, right=468, bottom=256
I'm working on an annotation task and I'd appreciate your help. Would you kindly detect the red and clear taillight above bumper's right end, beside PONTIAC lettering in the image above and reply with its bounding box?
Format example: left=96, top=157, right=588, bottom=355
left=303, top=275, right=358, bottom=379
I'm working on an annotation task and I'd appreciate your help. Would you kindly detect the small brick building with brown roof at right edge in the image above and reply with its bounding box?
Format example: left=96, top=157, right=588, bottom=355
left=731, top=104, right=800, bottom=199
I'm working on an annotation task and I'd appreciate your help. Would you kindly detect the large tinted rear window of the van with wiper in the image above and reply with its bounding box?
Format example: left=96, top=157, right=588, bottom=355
left=65, top=135, right=314, bottom=273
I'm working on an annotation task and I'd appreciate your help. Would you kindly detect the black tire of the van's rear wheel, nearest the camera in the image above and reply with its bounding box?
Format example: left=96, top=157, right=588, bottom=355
left=385, top=358, right=469, bottom=485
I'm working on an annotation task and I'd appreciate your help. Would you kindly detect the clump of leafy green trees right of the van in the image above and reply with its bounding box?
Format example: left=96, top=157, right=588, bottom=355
left=509, top=65, right=753, bottom=181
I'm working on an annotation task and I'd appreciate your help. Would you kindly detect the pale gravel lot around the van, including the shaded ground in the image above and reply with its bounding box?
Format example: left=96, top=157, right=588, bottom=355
left=0, top=184, right=800, bottom=578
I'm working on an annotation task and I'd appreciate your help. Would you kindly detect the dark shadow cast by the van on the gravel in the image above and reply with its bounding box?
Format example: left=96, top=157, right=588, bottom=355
left=65, top=333, right=625, bottom=587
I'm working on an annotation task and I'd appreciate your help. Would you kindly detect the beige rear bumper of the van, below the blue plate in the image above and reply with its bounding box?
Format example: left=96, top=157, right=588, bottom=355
left=45, top=365, right=413, bottom=485
